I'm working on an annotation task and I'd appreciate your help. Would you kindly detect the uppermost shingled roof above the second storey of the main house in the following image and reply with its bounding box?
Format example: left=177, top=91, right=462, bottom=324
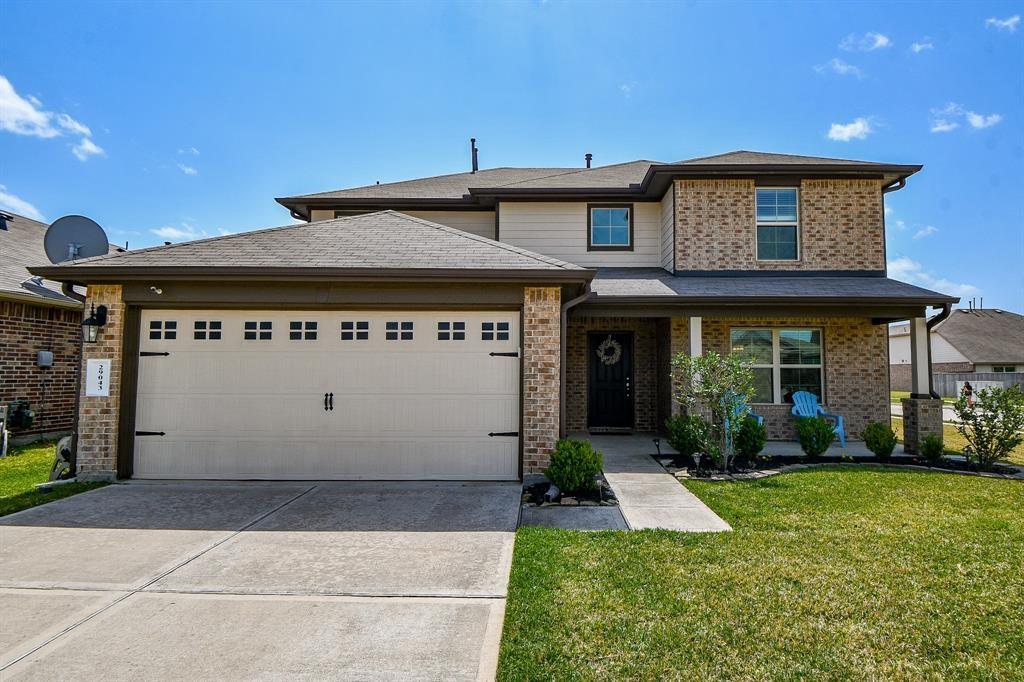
left=276, top=150, right=922, bottom=217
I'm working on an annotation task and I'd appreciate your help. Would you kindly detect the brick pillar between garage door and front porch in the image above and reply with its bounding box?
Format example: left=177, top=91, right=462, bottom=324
left=519, top=287, right=561, bottom=474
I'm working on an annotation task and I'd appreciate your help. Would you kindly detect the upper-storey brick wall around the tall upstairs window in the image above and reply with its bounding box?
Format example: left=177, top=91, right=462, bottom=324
left=675, top=179, right=886, bottom=270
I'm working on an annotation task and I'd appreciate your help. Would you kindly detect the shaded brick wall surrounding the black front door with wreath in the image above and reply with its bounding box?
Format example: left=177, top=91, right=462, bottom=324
left=565, top=317, right=660, bottom=432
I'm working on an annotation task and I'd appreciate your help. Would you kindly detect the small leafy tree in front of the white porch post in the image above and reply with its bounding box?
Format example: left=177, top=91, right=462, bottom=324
left=672, top=350, right=754, bottom=469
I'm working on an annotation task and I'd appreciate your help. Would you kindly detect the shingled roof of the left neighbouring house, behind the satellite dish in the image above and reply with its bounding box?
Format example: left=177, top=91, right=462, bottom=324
left=0, top=211, right=82, bottom=308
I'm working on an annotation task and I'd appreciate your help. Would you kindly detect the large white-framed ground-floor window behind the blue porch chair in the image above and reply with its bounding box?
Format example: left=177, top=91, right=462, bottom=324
left=729, top=328, right=824, bottom=403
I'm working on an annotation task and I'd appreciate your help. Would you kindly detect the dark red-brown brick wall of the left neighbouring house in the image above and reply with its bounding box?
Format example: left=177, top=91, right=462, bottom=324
left=0, top=301, right=82, bottom=439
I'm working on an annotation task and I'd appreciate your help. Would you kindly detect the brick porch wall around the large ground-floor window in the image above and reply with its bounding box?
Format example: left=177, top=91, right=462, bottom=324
left=703, top=317, right=889, bottom=440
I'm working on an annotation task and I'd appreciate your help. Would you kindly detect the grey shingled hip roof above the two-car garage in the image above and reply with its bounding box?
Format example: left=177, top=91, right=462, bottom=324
left=33, top=206, right=593, bottom=282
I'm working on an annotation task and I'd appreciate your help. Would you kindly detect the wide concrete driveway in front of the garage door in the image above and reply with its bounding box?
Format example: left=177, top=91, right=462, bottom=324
left=0, top=482, right=520, bottom=680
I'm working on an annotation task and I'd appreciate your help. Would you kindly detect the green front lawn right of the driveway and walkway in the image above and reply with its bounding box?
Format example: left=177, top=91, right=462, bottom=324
left=499, top=468, right=1024, bottom=680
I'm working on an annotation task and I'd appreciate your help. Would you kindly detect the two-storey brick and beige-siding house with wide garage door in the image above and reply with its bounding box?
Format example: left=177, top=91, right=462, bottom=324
left=34, top=152, right=957, bottom=479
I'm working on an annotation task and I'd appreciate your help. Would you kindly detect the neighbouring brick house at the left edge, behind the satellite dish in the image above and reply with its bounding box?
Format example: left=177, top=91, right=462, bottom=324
left=0, top=208, right=82, bottom=440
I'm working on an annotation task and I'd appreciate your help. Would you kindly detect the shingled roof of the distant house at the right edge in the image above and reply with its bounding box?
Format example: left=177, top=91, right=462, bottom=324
left=933, top=308, right=1024, bottom=365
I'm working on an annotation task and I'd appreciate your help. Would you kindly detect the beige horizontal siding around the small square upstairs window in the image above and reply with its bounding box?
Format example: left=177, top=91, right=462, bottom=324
left=501, top=202, right=662, bottom=267
